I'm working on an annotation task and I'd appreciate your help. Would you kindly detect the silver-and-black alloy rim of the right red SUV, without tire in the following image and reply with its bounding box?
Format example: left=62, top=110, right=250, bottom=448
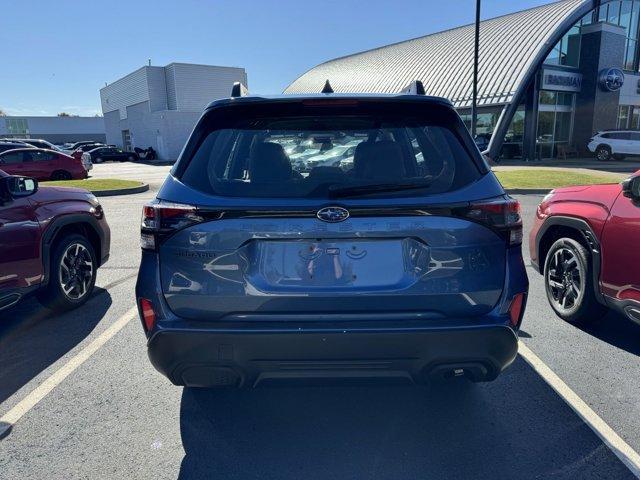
left=546, top=247, right=585, bottom=312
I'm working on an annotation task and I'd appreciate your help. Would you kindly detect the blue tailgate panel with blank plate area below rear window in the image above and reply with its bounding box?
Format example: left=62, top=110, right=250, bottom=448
left=160, top=216, right=505, bottom=320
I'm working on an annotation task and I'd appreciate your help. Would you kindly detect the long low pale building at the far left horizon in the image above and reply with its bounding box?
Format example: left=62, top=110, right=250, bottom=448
left=0, top=116, right=105, bottom=143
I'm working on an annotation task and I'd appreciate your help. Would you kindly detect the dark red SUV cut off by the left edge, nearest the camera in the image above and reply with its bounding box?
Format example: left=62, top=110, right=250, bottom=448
left=0, top=170, right=111, bottom=310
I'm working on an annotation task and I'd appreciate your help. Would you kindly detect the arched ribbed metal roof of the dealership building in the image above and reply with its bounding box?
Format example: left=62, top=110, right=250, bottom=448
left=285, top=0, right=593, bottom=107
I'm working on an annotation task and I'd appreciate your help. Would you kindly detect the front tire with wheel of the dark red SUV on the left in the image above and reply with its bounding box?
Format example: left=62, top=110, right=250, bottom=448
left=37, top=234, right=98, bottom=312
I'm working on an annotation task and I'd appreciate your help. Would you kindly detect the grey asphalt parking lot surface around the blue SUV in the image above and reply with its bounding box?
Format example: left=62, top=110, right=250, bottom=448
left=0, top=163, right=640, bottom=479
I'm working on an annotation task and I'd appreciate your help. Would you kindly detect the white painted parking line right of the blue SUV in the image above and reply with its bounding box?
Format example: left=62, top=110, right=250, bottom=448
left=518, top=341, right=640, bottom=478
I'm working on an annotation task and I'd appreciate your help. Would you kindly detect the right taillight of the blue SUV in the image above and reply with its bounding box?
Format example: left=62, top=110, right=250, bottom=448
left=458, top=197, right=522, bottom=245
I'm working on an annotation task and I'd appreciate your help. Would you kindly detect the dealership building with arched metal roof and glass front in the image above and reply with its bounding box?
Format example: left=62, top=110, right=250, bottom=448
left=285, top=0, right=640, bottom=160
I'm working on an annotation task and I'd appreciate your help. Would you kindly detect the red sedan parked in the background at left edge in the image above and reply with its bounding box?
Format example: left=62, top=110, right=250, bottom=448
left=0, top=148, right=87, bottom=180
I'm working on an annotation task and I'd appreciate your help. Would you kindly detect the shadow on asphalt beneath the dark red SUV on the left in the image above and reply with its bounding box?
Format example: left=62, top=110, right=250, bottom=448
left=0, top=287, right=111, bottom=403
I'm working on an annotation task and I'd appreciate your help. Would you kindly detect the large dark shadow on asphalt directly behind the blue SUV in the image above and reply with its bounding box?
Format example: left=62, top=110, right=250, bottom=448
left=179, top=358, right=634, bottom=480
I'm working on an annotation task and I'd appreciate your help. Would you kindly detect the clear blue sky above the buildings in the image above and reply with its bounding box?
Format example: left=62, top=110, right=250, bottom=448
left=0, top=0, right=549, bottom=115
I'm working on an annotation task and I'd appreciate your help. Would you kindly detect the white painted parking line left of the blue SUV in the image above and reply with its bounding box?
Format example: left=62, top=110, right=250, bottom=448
left=0, top=307, right=137, bottom=438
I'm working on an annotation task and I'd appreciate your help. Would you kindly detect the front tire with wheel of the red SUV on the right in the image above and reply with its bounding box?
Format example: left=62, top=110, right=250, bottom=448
left=544, top=238, right=607, bottom=325
